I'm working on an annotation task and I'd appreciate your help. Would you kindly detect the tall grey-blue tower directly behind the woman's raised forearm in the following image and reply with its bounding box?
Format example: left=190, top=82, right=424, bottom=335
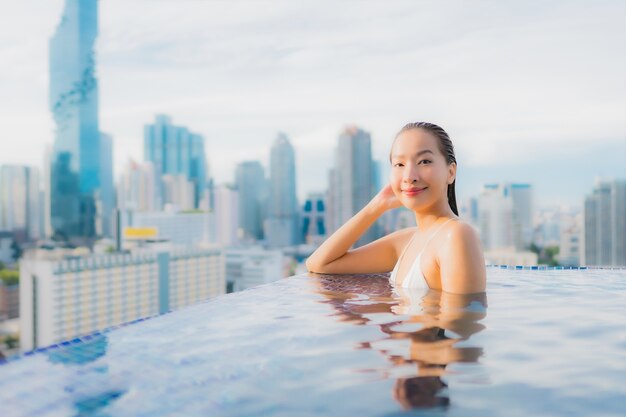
left=327, top=126, right=379, bottom=246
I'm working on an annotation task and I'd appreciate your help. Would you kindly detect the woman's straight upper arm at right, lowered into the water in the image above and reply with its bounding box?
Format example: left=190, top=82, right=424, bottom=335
left=439, top=222, right=487, bottom=294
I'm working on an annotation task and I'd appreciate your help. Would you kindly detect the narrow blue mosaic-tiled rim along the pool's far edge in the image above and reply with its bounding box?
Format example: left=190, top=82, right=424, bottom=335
left=0, top=265, right=626, bottom=366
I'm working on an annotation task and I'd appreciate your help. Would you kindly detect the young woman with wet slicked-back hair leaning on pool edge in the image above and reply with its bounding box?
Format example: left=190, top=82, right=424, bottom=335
left=306, top=122, right=486, bottom=294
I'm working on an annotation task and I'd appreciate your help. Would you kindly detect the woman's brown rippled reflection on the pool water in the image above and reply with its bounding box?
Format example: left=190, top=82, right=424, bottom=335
left=311, top=275, right=487, bottom=409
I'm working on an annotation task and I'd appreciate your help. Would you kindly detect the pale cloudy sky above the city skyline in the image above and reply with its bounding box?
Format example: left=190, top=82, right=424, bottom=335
left=0, top=0, right=626, bottom=205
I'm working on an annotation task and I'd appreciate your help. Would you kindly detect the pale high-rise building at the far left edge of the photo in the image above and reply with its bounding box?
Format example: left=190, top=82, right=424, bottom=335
left=0, top=165, right=43, bottom=241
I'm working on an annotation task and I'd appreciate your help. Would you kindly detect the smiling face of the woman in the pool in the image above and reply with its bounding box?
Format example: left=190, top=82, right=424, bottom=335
left=390, top=129, right=456, bottom=210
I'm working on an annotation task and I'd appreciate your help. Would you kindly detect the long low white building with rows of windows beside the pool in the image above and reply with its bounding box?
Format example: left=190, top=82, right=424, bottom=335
left=20, top=249, right=225, bottom=351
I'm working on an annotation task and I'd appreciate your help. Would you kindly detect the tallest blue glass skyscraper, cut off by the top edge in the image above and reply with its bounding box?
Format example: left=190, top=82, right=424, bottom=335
left=50, top=0, right=113, bottom=244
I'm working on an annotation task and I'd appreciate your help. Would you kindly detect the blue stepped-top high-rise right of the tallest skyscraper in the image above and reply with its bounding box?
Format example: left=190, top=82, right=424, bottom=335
left=144, top=115, right=207, bottom=208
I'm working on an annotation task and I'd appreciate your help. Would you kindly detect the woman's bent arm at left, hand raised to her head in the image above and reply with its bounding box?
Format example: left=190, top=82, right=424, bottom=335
left=306, top=185, right=406, bottom=274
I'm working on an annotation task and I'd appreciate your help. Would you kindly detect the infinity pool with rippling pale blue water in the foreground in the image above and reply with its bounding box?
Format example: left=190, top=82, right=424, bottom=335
left=0, top=267, right=626, bottom=417
